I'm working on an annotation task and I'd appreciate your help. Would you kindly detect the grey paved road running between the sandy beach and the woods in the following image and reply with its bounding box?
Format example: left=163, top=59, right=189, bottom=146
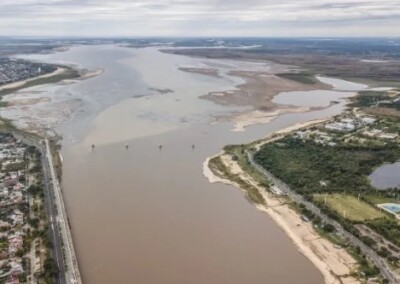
left=247, top=152, right=400, bottom=284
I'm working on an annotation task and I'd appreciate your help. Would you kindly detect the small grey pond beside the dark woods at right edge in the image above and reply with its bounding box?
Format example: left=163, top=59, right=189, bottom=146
left=369, top=162, right=400, bottom=189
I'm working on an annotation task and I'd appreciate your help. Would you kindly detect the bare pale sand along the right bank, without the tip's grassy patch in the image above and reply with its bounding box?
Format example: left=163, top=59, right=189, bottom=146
left=203, top=120, right=361, bottom=284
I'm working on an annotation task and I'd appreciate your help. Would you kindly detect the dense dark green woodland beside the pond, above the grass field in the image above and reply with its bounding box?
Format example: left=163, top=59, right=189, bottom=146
left=254, top=137, right=400, bottom=195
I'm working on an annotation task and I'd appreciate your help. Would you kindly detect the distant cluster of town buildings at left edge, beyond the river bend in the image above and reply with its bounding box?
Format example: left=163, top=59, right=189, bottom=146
left=0, top=58, right=56, bottom=85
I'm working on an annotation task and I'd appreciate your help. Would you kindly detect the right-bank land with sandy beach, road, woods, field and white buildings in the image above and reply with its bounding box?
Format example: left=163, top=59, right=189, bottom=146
left=205, top=87, right=400, bottom=283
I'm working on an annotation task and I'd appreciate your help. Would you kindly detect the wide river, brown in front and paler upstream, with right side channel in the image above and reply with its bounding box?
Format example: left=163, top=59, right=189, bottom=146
left=3, top=46, right=366, bottom=284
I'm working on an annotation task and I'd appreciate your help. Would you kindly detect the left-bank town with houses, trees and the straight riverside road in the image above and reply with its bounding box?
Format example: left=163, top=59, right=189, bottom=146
left=0, top=126, right=82, bottom=284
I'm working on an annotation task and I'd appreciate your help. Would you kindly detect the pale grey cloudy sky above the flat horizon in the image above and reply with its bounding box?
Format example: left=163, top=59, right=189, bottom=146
left=0, top=0, right=400, bottom=37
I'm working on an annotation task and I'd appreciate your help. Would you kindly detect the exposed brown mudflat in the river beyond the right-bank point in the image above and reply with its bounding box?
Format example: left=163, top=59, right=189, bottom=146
left=179, top=63, right=334, bottom=132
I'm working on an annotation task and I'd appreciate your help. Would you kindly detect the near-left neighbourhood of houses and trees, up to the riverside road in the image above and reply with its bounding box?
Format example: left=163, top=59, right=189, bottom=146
left=0, top=132, right=57, bottom=284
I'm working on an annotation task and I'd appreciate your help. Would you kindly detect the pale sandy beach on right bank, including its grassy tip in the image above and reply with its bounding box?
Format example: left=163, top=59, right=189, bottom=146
left=203, top=120, right=361, bottom=284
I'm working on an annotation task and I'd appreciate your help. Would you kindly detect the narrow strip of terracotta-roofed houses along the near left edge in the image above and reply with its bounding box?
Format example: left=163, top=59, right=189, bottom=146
left=0, top=133, right=27, bottom=284
